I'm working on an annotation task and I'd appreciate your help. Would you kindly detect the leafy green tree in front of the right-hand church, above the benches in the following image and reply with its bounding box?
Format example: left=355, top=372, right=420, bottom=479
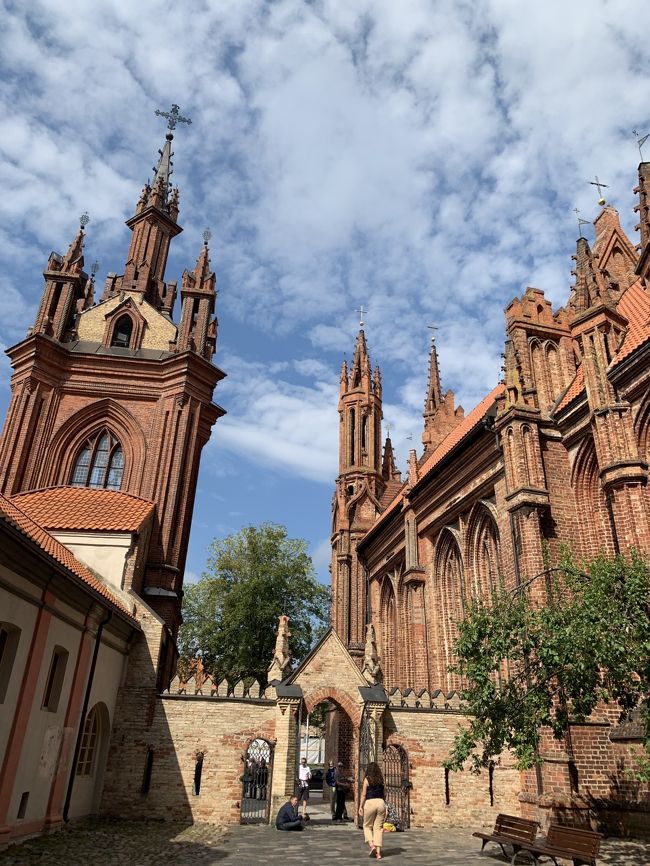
left=447, top=554, right=650, bottom=778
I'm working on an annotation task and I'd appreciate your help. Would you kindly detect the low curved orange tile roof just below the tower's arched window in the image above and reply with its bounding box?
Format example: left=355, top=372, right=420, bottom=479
left=12, top=487, right=154, bottom=532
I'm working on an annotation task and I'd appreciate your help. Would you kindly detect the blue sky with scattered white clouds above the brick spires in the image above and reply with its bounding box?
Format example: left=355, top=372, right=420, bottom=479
left=0, top=0, right=650, bottom=579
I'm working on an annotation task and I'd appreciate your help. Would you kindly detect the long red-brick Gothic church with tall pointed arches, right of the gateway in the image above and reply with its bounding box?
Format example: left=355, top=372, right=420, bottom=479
left=331, top=172, right=650, bottom=820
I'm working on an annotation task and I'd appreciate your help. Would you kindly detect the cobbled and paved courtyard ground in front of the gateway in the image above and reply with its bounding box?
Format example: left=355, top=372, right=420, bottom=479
left=0, top=820, right=650, bottom=866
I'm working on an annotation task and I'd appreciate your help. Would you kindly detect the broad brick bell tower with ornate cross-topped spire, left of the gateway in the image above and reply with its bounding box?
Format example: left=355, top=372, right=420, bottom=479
left=0, top=105, right=224, bottom=637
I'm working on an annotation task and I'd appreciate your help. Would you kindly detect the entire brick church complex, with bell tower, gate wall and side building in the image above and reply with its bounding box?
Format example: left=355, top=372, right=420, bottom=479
left=0, top=107, right=650, bottom=844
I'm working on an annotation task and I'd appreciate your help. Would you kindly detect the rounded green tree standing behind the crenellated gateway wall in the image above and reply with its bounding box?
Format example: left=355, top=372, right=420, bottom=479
left=179, top=523, right=329, bottom=684
